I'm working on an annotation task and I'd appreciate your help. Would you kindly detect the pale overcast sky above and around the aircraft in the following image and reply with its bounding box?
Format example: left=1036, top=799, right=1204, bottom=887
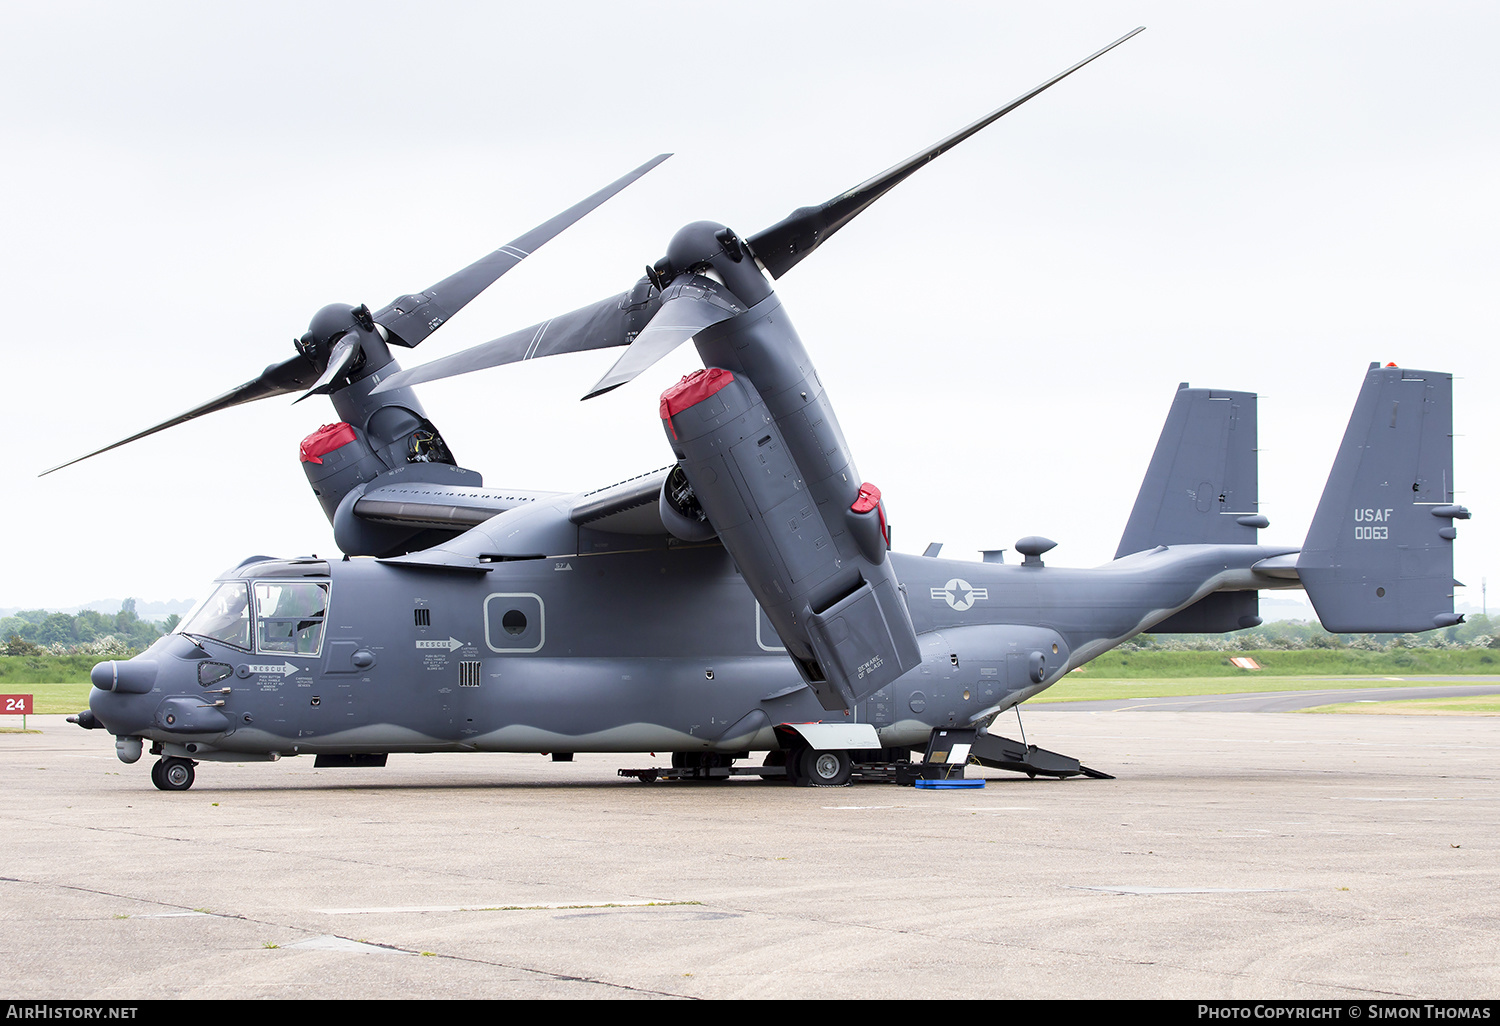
left=0, top=0, right=1500, bottom=618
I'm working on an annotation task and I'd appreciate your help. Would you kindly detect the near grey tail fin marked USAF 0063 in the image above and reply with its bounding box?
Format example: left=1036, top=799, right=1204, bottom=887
left=1298, top=363, right=1469, bottom=633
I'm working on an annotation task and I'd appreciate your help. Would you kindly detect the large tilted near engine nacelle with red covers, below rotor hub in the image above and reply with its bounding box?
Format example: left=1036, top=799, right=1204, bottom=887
left=660, top=297, right=921, bottom=710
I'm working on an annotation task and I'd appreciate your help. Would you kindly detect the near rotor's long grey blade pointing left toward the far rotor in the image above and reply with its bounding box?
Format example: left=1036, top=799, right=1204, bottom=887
left=371, top=278, right=660, bottom=395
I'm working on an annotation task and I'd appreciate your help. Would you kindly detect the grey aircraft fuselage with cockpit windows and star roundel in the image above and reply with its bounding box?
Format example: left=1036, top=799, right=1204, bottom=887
left=90, top=528, right=1289, bottom=759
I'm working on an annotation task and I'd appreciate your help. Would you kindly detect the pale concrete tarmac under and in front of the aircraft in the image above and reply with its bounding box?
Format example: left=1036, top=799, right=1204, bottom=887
left=0, top=707, right=1500, bottom=1004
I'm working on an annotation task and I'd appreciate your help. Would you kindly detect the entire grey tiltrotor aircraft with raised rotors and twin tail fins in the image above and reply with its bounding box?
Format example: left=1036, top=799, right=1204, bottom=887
left=55, top=30, right=1469, bottom=791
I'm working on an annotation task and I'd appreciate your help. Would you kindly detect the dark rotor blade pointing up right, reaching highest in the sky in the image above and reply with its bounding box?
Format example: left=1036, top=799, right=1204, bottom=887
left=746, top=26, right=1145, bottom=278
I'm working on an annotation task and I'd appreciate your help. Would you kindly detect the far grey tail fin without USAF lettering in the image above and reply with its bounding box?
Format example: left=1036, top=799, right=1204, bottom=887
left=1115, top=383, right=1266, bottom=560
